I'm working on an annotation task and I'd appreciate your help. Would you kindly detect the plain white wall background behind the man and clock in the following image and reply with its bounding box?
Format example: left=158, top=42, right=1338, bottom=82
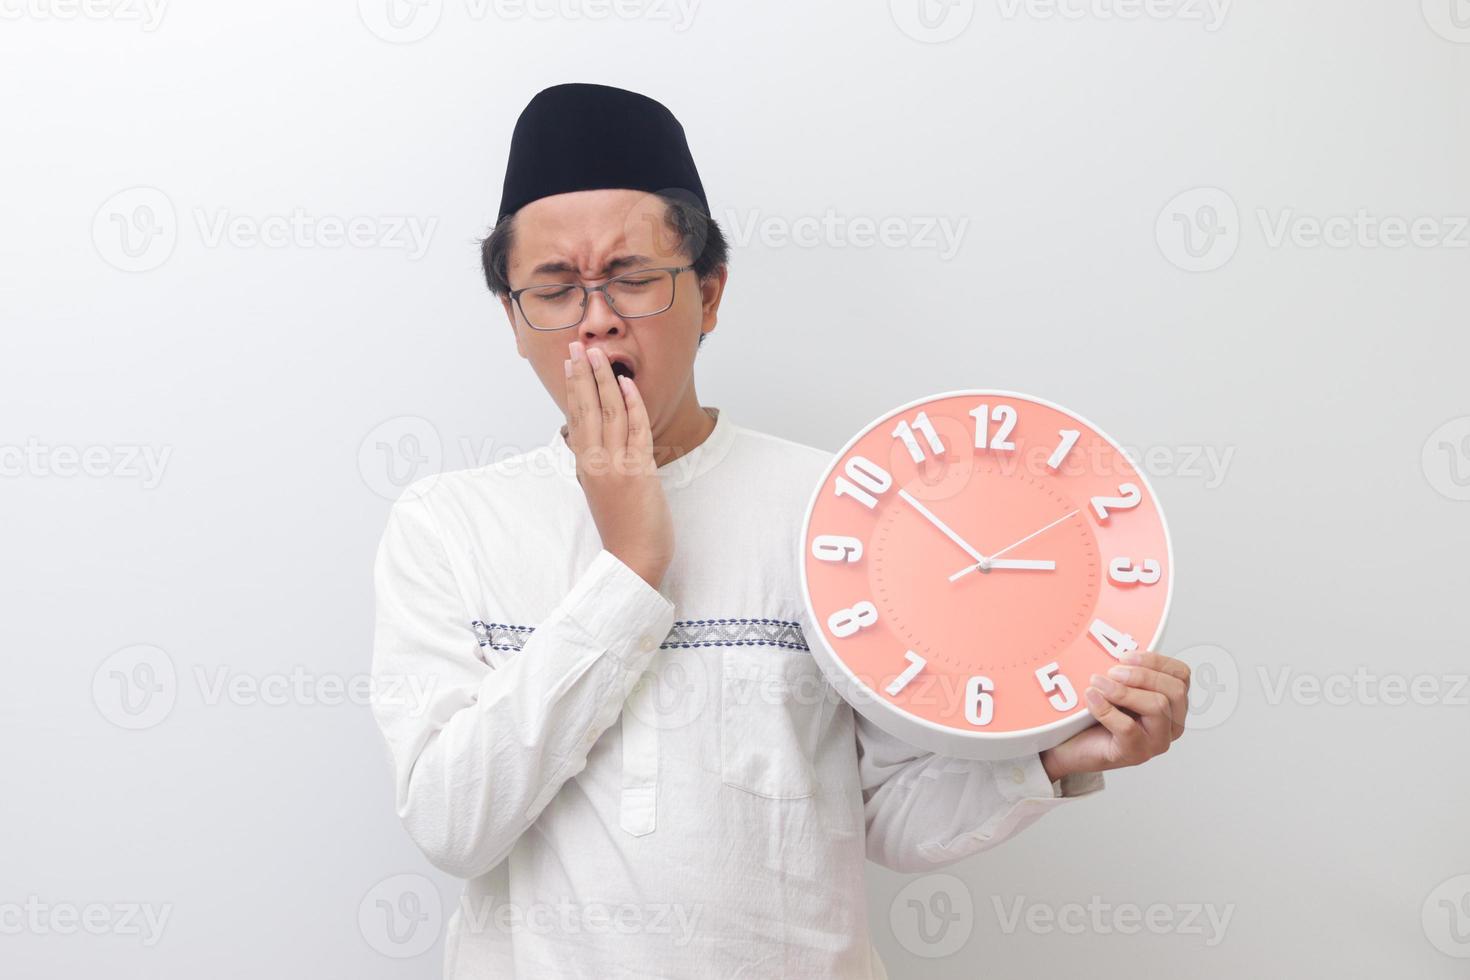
left=0, top=0, right=1470, bottom=979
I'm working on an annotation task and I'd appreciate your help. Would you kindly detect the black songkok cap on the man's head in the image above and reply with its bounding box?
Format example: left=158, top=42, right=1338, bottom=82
left=497, top=82, right=710, bottom=220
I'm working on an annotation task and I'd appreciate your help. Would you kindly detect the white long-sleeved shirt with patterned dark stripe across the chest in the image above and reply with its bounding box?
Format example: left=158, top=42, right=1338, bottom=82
left=373, top=408, right=1103, bottom=980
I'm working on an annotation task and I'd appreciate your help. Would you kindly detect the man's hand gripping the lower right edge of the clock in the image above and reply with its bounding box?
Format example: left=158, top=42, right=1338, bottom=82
left=1041, top=649, right=1189, bottom=780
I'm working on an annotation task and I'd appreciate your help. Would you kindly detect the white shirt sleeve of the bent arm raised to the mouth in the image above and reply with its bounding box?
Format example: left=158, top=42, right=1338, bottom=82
left=372, top=488, right=673, bottom=879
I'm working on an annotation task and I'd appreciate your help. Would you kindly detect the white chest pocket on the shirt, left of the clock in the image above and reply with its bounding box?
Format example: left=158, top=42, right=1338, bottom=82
left=720, top=646, right=823, bottom=799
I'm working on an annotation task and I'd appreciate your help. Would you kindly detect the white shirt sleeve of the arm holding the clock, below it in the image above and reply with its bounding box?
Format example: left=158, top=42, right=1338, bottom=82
left=853, top=711, right=1104, bottom=871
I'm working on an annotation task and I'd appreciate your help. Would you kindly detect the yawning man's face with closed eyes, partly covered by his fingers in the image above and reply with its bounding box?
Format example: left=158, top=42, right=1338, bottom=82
left=503, top=190, right=726, bottom=435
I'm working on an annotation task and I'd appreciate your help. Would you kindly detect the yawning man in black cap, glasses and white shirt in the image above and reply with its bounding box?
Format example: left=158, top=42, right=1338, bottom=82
left=373, top=84, right=1188, bottom=980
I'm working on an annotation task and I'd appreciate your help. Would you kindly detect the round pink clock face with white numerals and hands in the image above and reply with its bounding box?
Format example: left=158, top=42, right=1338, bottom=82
left=803, top=391, right=1172, bottom=755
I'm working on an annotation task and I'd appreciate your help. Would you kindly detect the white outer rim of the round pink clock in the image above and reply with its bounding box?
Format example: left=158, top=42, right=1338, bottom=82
left=797, top=388, right=1175, bottom=760
